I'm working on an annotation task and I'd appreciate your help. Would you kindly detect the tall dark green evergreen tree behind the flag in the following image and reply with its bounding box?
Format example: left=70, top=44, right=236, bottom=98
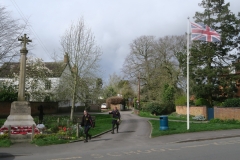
left=190, top=0, right=240, bottom=105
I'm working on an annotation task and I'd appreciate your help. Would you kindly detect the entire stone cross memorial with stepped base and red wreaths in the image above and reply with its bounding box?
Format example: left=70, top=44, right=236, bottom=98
left=0, top=34, right=39, bottom=142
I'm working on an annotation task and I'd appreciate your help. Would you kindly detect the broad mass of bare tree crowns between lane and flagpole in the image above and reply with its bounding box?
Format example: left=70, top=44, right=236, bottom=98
left=123, top=36, right=186, bottom=100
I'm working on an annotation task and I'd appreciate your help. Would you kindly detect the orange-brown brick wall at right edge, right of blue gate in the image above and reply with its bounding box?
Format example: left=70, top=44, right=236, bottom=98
left=214, top=107, right=240, bottom=120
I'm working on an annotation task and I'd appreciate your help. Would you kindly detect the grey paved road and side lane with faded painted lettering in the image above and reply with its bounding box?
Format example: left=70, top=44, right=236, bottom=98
left=0, top=111, right=240, bottom=160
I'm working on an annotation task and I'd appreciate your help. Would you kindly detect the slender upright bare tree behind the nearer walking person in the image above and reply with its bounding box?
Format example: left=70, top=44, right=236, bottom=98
left=61, top=18, right=101, bottom=120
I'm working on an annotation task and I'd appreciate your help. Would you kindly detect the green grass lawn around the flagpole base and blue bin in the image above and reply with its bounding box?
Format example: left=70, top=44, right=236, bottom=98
left=149, top=120, right=240, bottom=137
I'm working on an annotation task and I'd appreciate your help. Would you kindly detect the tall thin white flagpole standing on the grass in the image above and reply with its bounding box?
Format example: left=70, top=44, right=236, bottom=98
left=187, top=17, right=189, bottom=130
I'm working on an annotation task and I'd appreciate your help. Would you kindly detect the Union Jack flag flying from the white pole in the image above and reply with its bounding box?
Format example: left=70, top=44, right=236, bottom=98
left=191, top=22, right=220, bottom=42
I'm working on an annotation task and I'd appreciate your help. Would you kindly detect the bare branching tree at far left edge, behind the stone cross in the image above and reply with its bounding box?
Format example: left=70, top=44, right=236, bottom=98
left=0, top=6, right=26, bottom=65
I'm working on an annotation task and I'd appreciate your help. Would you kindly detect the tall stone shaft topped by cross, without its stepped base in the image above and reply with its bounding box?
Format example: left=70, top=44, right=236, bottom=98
left=18, top=34, right=32, bottom=101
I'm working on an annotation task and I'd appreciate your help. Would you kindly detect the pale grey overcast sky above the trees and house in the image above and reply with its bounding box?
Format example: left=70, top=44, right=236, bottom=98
left=0, top=0, right=240, bottom=80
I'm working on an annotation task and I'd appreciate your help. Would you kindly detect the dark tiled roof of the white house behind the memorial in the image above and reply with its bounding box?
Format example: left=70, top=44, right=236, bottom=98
left=0, top=62, right=67, bottom=78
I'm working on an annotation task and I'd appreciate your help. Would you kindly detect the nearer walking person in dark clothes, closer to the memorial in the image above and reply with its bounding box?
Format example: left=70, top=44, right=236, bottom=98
left=81, top=110, right=94, bottom=143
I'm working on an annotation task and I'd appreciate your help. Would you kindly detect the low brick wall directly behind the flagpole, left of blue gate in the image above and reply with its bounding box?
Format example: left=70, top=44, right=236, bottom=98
left=176, top=106, right=207, bottom=118
